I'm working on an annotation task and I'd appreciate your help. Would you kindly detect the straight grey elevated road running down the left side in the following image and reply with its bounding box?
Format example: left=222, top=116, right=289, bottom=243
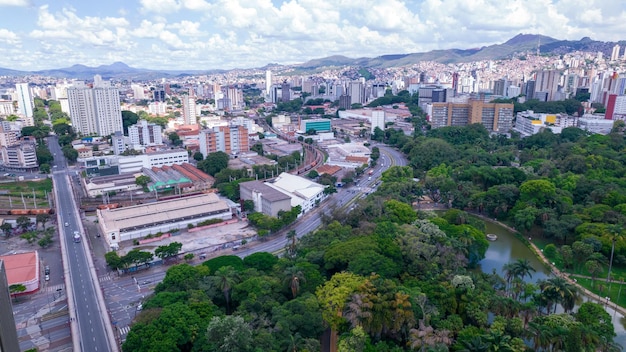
left=48, top=137, right=118, bottom=352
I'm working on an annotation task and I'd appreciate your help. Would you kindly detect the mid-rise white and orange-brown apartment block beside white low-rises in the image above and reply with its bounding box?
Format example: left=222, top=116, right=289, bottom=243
left=198, top=126, right=250, bottom=158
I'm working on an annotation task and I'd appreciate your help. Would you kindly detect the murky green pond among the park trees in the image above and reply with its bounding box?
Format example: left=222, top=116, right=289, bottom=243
left=479, top=217, right=626, bottom=346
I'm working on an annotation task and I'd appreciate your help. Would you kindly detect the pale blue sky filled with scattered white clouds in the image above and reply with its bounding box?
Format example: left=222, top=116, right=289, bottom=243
left=0, top=0, right=626, bottom=71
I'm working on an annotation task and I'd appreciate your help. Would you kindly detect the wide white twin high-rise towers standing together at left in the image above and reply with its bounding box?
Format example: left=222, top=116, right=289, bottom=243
left=67, top=81, right=123, bottom=136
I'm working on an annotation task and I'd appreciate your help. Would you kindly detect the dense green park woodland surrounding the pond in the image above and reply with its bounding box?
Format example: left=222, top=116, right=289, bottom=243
left=123, top=123, right=626, bottom=352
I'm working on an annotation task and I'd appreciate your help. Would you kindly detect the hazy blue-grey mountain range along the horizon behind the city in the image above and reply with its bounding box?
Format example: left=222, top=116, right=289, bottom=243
left=0, top=34, right=626, bottom=80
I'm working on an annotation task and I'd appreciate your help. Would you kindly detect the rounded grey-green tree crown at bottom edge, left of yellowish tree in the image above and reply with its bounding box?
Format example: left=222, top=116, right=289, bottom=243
left=206, top=315, right=252, bottom=352
